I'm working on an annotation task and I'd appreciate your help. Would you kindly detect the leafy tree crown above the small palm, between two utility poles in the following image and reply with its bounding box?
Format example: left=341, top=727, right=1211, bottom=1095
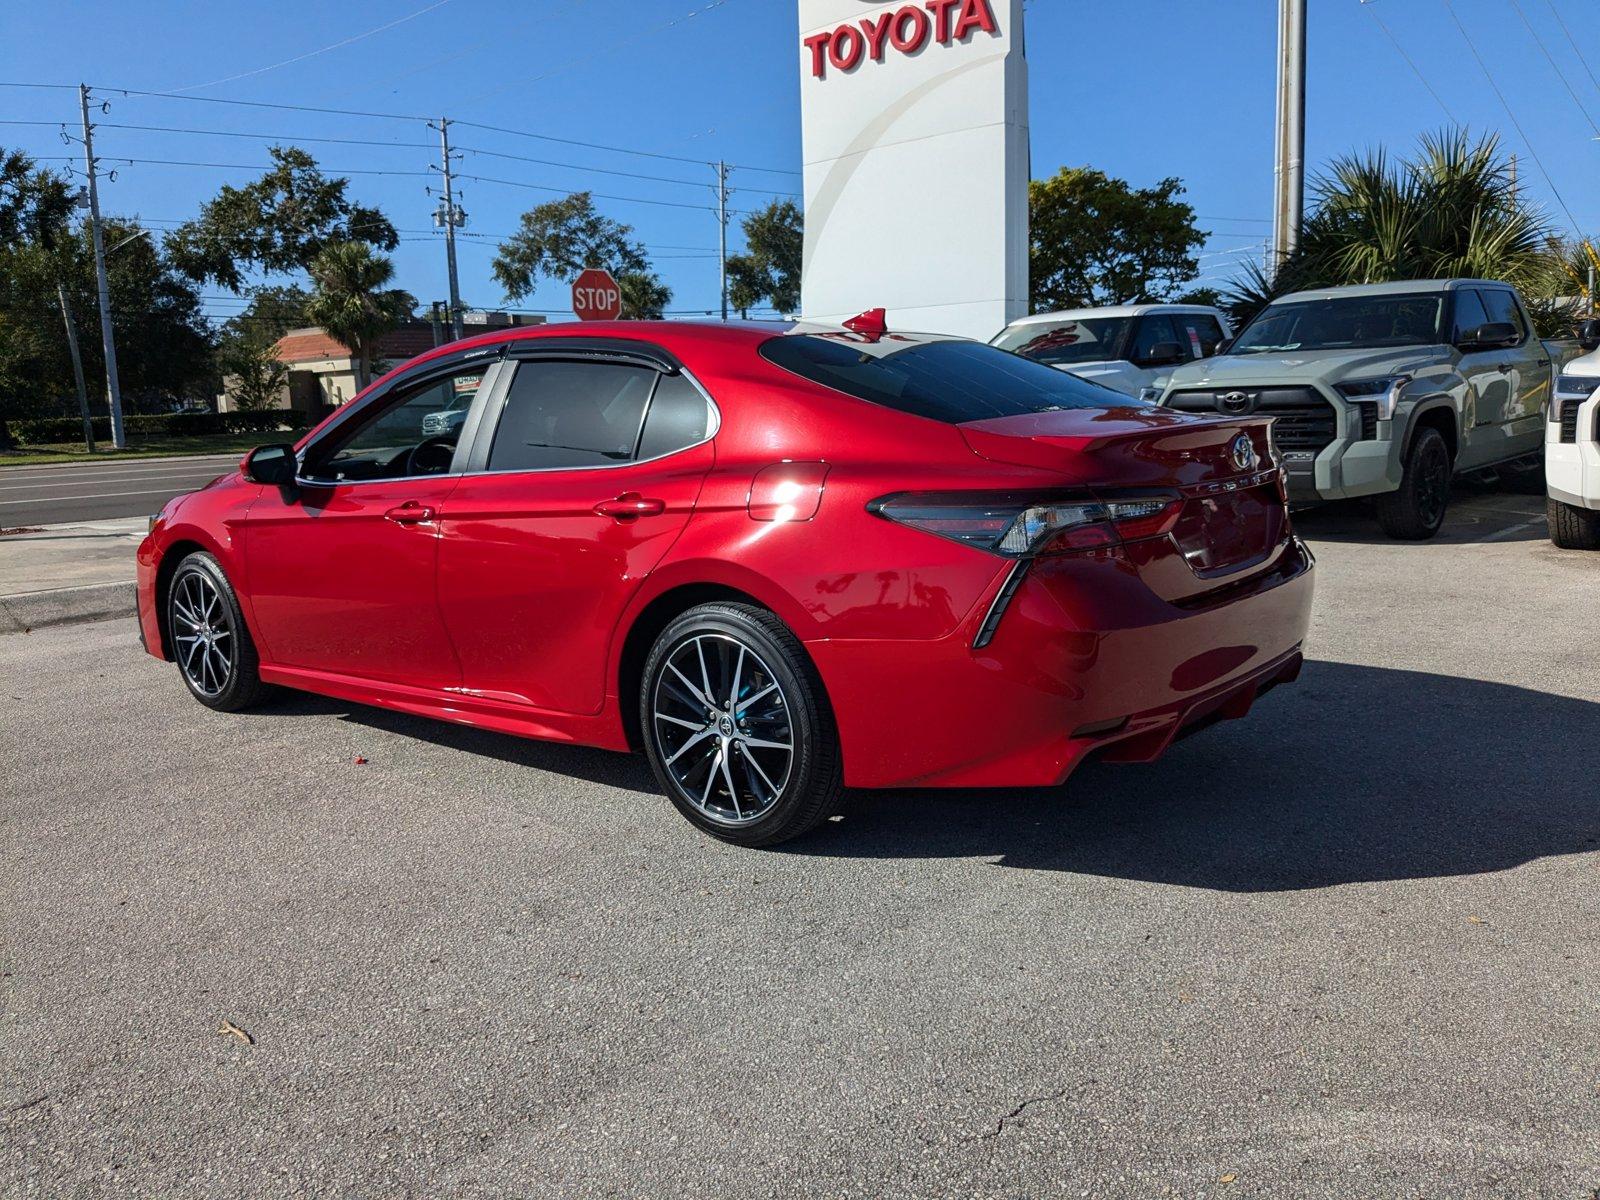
left=166, top=146, right=400, bottom=291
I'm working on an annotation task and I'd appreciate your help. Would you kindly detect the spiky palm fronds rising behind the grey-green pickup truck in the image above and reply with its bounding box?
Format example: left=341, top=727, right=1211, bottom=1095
left=1227, top=130, right=1557, bottom=334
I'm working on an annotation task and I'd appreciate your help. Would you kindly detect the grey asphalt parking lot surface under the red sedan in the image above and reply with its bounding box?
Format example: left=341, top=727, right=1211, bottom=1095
left=0, top=493, right=1600, bottom=1200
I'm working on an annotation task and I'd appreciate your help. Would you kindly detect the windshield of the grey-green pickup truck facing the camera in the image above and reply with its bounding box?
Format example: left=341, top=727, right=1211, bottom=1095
left=1229, top=293, right=1442, bottom=354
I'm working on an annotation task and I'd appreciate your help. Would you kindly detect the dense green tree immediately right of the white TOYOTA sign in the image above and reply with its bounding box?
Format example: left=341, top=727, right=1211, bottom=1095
left=1027, top=166, right=1206, bottom=312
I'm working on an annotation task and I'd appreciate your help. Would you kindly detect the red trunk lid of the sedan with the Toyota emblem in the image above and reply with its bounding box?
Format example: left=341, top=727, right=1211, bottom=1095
left=957, top=408, right=1290, bottom=602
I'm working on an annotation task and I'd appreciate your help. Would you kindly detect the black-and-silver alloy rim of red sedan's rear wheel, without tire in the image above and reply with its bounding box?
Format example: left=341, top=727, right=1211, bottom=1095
left=651, top=634, right=795, bottom=826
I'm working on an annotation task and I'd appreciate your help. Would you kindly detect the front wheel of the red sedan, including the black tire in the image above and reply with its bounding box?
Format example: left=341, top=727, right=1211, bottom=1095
left=163, top=550, right=270, bottom=712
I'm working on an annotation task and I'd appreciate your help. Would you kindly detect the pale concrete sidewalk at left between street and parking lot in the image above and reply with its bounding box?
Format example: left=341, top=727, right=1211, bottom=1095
left=0, top=517, right=147, bottom=634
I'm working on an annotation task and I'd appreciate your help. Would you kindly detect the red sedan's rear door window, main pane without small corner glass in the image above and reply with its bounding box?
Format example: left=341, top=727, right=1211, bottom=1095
left=488, top=362, right=659, bottom=470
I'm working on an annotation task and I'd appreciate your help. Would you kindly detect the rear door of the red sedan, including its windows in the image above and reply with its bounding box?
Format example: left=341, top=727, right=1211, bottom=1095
left=438, top=354, right=715, bottom=714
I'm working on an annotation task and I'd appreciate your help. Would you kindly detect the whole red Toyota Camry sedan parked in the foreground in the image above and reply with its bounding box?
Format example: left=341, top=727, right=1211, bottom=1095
left=139, top=314, right=1312, bottom=845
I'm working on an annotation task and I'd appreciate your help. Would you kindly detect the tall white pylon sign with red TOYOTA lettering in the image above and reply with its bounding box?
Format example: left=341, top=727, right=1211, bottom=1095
left=797, top=0, right=1029, bottom=339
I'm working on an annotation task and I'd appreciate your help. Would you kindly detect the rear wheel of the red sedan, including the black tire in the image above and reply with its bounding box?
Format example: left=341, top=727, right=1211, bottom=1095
left=638, top=603, right=843, bottom=846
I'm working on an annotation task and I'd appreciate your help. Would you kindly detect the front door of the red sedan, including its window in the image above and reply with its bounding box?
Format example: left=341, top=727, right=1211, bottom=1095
left=240, top=350, right=499, bottom=688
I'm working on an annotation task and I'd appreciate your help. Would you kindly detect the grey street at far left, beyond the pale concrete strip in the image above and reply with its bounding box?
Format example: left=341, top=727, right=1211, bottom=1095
left=0, top=454, right=243, bottom=528
